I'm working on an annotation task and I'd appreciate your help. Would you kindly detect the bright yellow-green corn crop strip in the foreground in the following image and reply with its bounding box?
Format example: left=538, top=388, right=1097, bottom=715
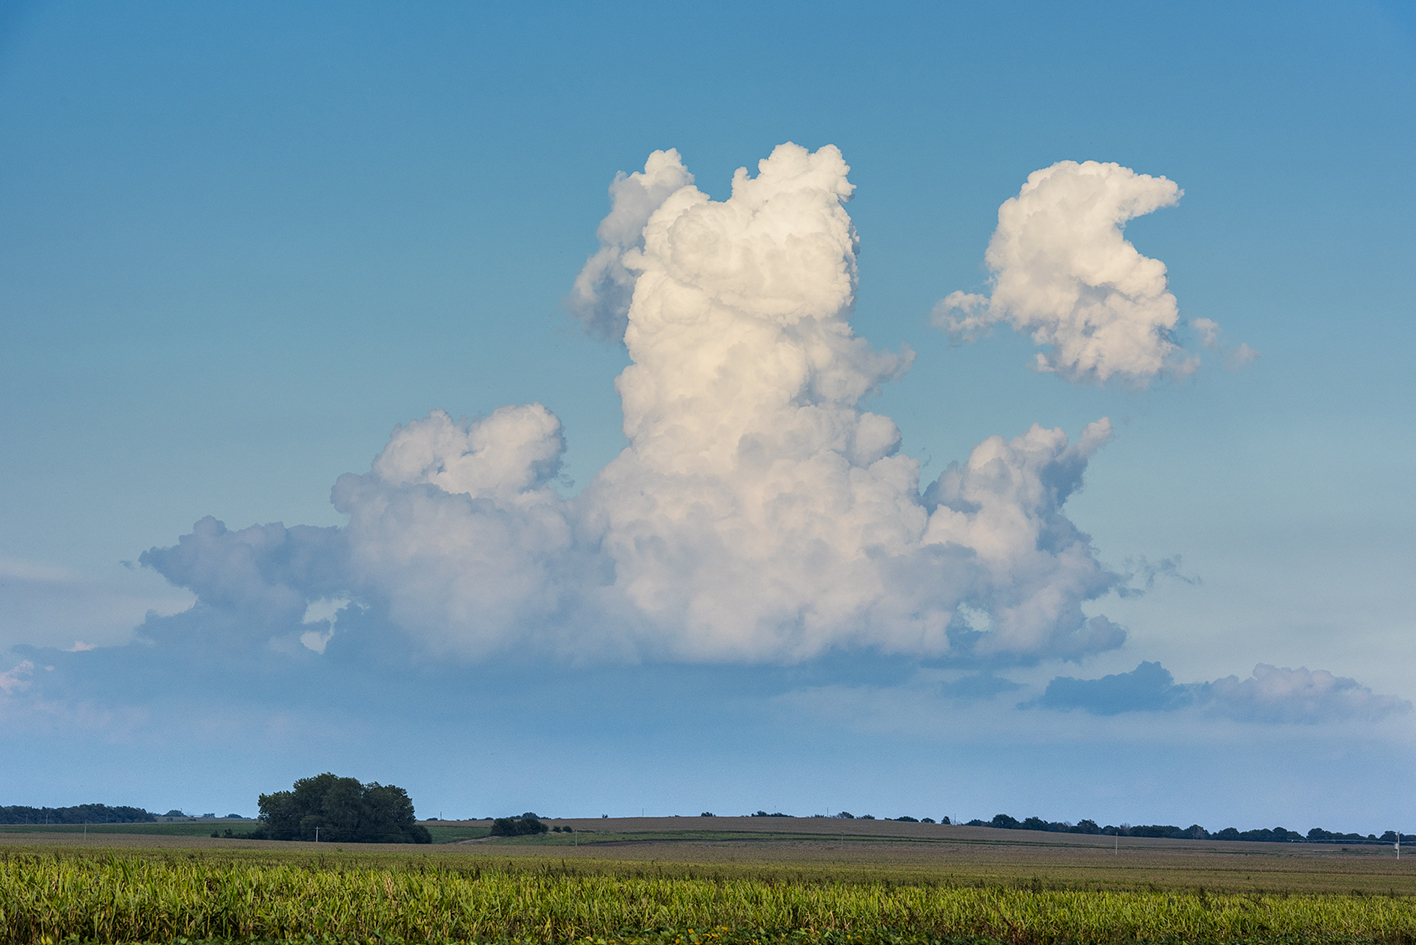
left=0, top=854, right=1416, bottom=945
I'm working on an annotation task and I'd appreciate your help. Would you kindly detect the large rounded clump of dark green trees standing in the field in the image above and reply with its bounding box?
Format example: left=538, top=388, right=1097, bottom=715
left=249, top=772, right=432, bottom=843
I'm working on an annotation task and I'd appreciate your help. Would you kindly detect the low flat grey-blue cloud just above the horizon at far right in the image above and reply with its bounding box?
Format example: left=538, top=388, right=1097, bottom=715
left=1020, top=662, right=1412, bottom=724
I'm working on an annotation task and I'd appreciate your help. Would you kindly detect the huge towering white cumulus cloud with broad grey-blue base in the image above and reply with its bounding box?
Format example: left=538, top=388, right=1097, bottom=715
left=138, top=145, right=1124, bottom=663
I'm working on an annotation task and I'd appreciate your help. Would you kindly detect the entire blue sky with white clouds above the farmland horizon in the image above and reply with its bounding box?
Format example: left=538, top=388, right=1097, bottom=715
left=0, top=1, right=1416, bottom=833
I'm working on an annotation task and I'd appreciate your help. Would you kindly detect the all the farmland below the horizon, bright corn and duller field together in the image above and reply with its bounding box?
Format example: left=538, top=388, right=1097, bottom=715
left=0, top=817, right=1416, bottom=945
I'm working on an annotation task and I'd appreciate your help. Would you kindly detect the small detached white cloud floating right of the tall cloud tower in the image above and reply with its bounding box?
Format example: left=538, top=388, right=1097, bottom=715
left=935, top=160, right=1214, bottom=384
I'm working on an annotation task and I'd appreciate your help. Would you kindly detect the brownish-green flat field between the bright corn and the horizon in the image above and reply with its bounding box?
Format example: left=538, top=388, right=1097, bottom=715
left=0, top=817, right=1416, bottom=897
